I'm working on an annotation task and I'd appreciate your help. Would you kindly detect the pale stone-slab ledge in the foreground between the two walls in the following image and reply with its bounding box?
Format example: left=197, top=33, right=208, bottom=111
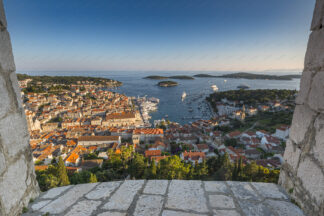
left=24, top=180, right=304, bottom=216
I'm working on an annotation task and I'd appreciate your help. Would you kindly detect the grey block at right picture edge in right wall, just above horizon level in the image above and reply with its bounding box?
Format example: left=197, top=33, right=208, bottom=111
left=304, top=28, right=324, bottom=71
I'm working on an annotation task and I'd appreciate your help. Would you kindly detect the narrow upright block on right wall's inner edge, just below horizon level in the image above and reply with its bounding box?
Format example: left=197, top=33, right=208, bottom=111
left=296, top=71, right=314, bottom=105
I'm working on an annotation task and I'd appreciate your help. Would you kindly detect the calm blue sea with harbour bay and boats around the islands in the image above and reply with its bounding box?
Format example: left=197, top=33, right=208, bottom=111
left=18, top=71, right=300, bottom=125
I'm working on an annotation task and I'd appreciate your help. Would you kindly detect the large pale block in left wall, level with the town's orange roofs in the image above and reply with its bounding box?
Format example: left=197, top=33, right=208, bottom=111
left=0, top=113, right=29, bottom=157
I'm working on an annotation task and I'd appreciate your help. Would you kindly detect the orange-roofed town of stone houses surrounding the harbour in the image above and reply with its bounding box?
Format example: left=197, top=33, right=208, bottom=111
left=19, top=77, right=296, bottom=190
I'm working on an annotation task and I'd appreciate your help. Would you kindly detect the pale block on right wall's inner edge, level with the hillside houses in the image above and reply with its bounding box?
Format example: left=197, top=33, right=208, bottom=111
left=290, top=105, right=316, bottom=144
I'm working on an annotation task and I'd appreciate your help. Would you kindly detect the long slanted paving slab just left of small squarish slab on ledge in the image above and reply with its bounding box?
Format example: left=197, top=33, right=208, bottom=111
left=103, top=180, right=144, bottom=211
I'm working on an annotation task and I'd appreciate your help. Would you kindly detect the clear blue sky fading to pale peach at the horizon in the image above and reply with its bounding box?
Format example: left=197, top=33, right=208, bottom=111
left=4, top=0, right=315, bottom=72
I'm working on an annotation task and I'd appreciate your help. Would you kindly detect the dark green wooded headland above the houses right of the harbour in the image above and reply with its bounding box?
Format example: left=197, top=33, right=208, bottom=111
left=207, top=89, right=297, bottom=106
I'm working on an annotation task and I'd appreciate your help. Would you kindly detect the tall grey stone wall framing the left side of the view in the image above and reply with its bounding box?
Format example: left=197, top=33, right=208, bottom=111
left=0, top=0, right=39, bottom=215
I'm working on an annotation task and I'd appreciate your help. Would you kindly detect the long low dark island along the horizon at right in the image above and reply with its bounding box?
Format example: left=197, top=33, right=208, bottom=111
left=194, top=72, right=301, bottom=80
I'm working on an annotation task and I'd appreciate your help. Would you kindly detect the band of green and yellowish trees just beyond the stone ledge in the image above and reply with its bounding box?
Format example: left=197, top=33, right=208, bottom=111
left=36, top=147, right=279, bottom=191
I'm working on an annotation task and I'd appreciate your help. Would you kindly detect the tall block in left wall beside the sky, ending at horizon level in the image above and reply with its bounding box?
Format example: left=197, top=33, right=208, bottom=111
left=0, top=30, right=16, bottom=73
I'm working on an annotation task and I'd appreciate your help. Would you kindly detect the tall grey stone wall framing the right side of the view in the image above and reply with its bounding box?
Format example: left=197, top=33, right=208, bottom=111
left=279, top=0, right=324, bottom=215
